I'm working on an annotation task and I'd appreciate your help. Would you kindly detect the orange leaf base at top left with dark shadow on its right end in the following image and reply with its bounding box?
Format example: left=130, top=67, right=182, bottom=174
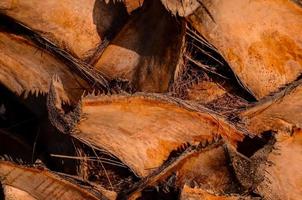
left=0, top=0, right=127, bottom=58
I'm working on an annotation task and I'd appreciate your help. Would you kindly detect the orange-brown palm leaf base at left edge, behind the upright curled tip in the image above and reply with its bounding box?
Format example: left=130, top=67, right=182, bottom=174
left=0, top=32, right=89, bottom=102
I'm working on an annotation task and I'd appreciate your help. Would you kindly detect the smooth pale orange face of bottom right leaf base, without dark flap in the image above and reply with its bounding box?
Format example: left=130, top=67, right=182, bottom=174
left=256, top=130, right=302, bottom=200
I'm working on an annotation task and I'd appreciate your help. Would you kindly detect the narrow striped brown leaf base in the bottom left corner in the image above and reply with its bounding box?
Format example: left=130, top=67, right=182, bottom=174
left=0, top=161, right=115, bottom=200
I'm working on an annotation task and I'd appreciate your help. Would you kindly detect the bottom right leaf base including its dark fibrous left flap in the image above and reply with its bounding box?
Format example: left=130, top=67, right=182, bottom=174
left=231, top=129, right=302, bottom=200
